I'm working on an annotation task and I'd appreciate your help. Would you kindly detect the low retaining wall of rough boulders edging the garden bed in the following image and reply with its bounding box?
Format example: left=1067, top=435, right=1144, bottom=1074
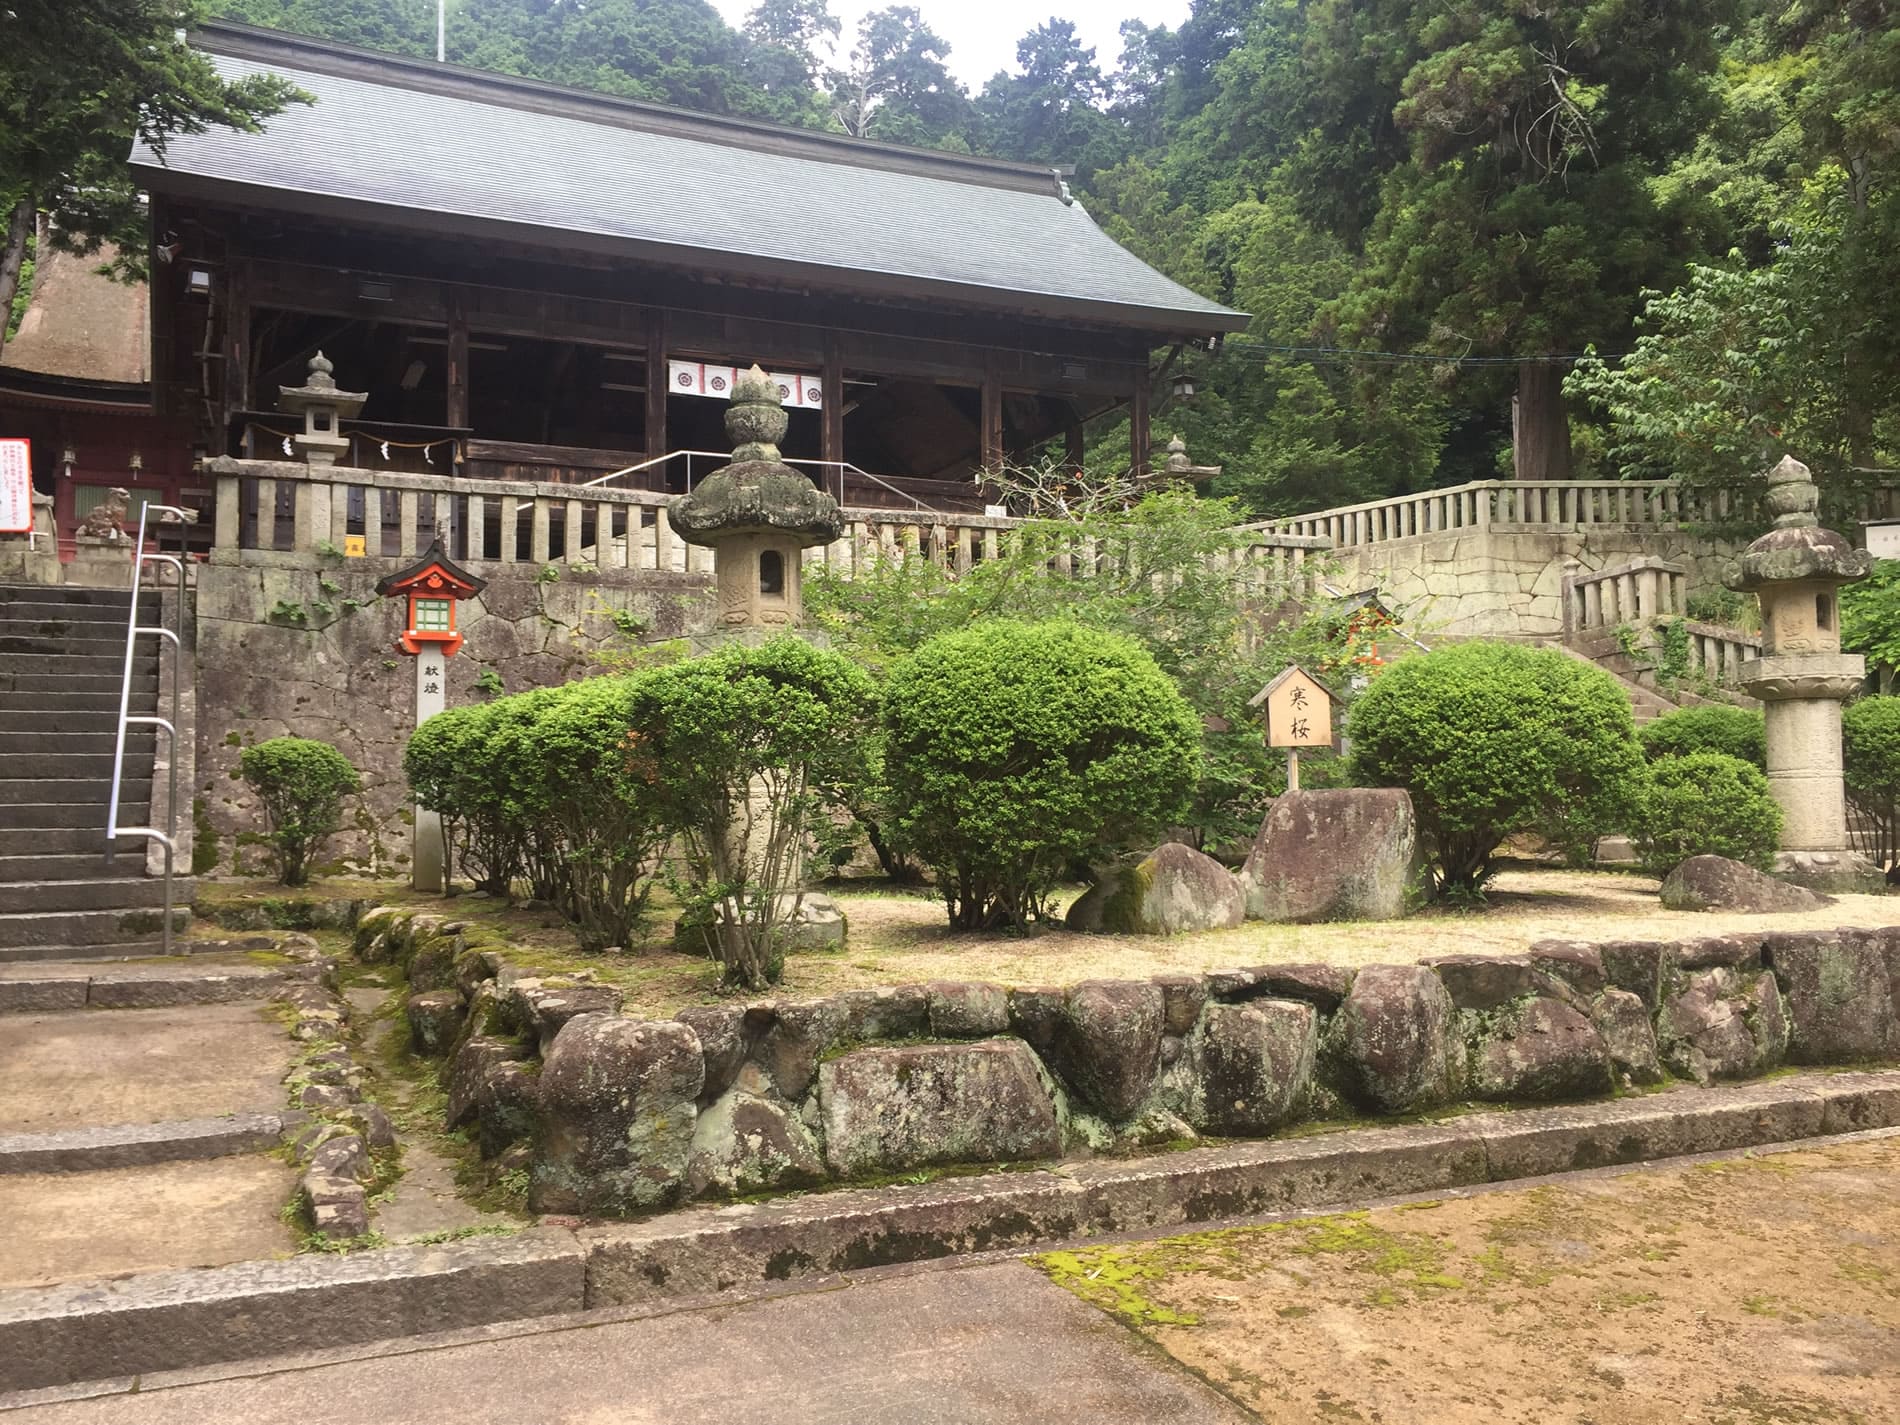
left=357, top=908, right=1900, bottom=1216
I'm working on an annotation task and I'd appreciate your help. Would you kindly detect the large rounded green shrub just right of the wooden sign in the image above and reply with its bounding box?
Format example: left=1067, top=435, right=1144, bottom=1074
left=1347, top=642, right=1642, bottom=895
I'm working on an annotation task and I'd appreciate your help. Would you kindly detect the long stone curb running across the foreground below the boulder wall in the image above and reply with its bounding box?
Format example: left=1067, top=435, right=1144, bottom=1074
left=0, top=1070, right=1900, bottom=1406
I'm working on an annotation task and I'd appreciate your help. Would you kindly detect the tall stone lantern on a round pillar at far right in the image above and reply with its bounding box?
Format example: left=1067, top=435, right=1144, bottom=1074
left=1723, top=456, right=1881, bottom=891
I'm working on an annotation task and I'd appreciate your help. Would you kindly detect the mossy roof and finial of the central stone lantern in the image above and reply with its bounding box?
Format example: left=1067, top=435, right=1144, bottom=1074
left=669, top=367, right=844, bottom=545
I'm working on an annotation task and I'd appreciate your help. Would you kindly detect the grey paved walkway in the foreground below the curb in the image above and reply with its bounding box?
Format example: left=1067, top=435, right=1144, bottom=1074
left=4, top=1262, right=1250, bottom=1425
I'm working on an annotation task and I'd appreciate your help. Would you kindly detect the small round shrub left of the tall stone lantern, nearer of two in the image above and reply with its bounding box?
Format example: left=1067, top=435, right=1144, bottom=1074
left=1630, top=752, right=1780, bottom=876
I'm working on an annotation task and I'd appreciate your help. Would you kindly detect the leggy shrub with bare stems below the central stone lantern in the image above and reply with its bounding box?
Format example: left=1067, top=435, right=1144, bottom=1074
left=625, top=638, right=876, bottom=990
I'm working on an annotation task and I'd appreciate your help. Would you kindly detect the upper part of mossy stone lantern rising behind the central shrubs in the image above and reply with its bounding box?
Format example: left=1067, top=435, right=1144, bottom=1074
left=671, top=367, right=844, bottom=631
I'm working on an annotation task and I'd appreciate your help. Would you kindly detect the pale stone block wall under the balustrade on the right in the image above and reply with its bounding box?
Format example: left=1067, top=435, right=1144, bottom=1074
left=1336, top=524, right=1740, bottom=642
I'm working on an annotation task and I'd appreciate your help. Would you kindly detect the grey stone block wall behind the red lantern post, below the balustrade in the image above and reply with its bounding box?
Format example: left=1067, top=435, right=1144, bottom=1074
left=192, top=551, right=711, bottom=874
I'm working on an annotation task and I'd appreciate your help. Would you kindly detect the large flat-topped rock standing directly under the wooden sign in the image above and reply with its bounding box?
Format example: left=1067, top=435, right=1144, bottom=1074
left=1241, top=789, right=1419, bottom=922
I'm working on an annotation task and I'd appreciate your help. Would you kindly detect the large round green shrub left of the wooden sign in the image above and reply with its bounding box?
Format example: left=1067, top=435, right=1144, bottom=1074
left=885, top=621, right=1201, bottom=929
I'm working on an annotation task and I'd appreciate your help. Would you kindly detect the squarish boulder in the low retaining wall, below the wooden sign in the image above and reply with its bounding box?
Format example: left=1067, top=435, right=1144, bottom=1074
left=1188, top=999, right=1319, bottom=1134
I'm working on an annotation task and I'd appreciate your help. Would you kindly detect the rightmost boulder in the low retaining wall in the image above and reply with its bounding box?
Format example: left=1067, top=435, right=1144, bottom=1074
left=1763, top=931, right=1900, bottom=1064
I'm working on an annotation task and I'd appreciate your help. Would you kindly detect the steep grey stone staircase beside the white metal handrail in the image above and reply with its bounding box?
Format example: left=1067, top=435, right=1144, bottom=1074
left=0, top=585, right=190, bottom=963
